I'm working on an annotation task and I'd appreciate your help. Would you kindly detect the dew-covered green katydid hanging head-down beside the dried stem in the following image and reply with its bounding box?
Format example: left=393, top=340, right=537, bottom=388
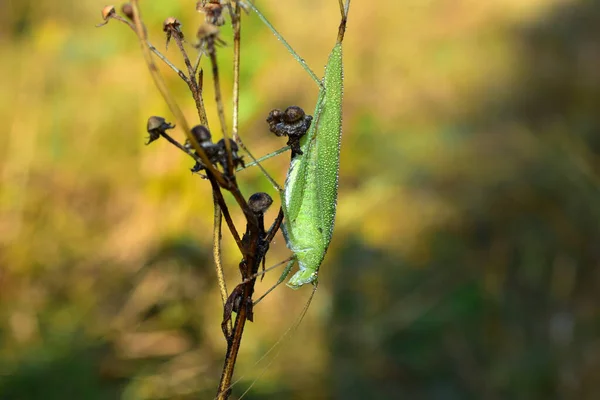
left=247, top=0, right=350, bottom=294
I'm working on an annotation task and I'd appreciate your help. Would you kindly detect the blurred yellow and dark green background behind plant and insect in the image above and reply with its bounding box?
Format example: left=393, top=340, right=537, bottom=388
left=0, top=0, right=600, bottom=400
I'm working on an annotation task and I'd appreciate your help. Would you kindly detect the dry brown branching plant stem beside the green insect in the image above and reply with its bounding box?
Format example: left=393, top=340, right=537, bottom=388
left=127, top=4, right=283, bottom=400
